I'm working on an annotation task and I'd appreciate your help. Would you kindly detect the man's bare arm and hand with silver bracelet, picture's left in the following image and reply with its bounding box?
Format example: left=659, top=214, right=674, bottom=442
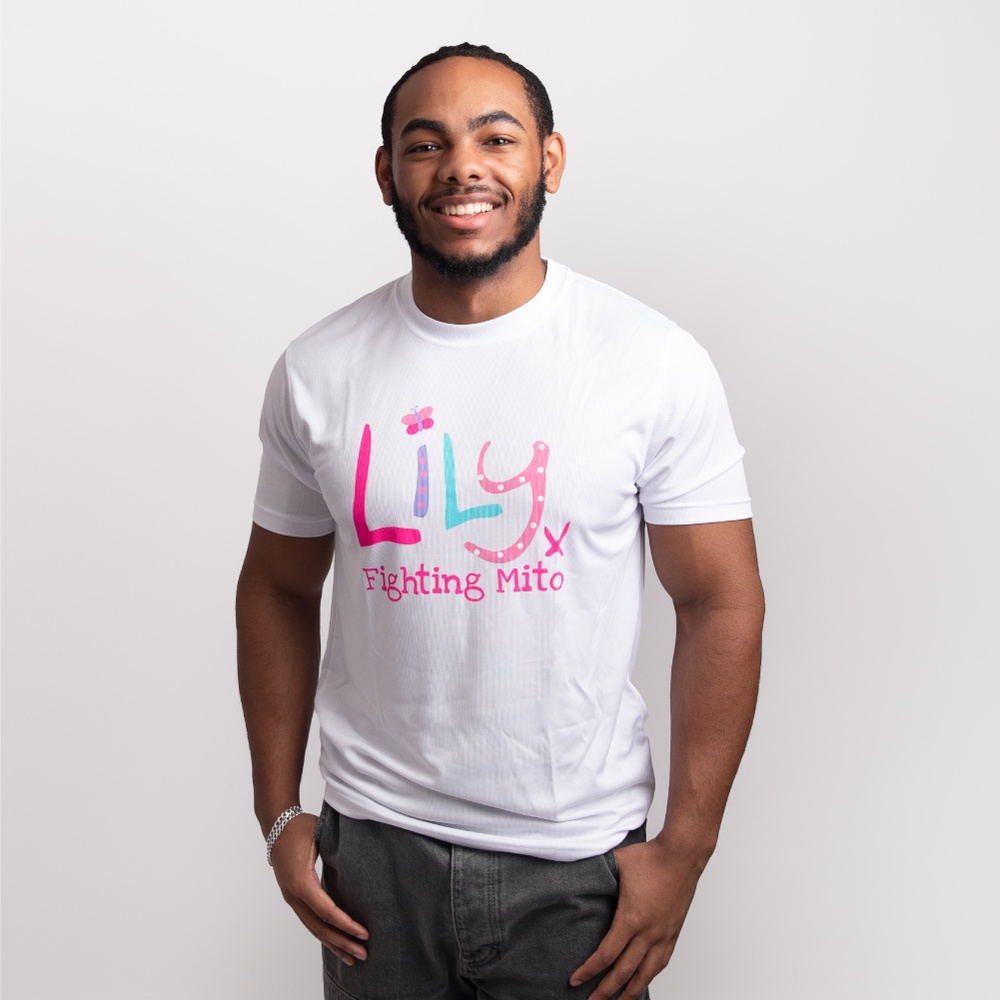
left=236, top=524, right=368, bottom=964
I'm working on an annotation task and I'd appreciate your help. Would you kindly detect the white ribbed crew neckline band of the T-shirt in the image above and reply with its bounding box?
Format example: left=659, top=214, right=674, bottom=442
left=396, top=260, right=568, bottom=347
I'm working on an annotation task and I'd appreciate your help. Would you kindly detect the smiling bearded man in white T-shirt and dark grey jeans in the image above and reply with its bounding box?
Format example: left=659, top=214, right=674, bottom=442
left=237, top=45, right=763, bottom=1000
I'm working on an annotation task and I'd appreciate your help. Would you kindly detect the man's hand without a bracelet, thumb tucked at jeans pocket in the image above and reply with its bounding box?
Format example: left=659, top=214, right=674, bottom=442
left=569, top=840, right=704, bottom=1000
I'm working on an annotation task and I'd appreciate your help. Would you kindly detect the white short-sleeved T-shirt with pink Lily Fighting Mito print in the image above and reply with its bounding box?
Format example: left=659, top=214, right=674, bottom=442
left=254, top=261, right=750, bottom=860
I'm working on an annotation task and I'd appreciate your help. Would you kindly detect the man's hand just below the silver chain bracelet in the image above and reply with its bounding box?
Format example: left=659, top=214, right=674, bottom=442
left=271, top=813, right=368, bottom=965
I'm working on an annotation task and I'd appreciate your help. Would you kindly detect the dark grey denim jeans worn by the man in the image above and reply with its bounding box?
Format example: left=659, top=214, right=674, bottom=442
left=316, top=805, right=648, bottom=1000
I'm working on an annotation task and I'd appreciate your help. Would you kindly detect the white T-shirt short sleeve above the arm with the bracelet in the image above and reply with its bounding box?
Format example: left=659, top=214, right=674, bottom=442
left=253, top=355, right=336, bottom=538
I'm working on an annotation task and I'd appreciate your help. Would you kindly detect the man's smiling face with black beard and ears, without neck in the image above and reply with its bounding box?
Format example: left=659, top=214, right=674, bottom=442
left=376, top=57, right=559, bottom=281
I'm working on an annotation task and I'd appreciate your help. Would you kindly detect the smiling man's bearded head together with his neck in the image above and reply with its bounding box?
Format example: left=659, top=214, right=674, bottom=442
left=375, top=51, right=565, bottom=324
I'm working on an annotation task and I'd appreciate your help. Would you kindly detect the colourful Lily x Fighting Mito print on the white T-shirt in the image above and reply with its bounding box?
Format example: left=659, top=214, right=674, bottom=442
left=353, top=406, right=570, bottom=602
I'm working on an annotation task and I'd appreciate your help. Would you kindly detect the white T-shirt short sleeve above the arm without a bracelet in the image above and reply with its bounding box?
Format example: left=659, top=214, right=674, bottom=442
left=636, top=340, right=750, bottom=524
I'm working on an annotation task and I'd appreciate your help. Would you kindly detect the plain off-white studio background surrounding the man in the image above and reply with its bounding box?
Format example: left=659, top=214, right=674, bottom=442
left=3, top=0, right=1000, bottom=1000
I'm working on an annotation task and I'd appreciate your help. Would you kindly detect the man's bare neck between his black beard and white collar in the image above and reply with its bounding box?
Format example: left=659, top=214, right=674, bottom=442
left=413, top=243, right=545, bottom=326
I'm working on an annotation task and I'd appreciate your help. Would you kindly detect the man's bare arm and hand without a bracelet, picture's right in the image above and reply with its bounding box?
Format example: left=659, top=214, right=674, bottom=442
left=570, top=520, right=764, bottom=1000
